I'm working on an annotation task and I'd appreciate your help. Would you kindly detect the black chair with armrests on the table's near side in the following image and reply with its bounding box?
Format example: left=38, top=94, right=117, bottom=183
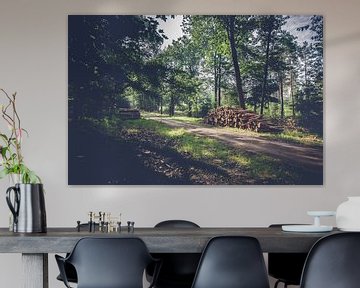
left=55, top=237, right=159, bottom=288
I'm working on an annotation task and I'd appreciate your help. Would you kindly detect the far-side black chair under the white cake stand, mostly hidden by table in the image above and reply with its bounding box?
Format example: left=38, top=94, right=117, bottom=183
left=268, top=224, right=307, bottom=288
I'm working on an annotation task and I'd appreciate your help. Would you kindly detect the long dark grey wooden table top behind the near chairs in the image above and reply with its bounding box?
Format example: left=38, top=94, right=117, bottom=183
left=0, top=227, right=339, bottom=253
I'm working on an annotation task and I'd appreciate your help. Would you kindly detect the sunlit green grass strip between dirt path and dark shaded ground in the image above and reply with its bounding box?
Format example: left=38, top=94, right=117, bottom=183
left=116, top=119, right=297, bottom=180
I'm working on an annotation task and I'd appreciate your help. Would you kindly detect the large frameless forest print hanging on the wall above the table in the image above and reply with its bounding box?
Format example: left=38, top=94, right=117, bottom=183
left=68, top=15, right=324, bottom=185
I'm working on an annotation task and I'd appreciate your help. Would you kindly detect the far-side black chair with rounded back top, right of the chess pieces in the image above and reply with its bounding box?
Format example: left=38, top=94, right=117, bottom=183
left=147, top=220, right=201, bottom=288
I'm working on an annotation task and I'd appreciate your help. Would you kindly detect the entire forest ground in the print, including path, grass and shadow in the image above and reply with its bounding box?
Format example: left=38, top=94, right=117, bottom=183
left=68, top=118, right=323, bottom=185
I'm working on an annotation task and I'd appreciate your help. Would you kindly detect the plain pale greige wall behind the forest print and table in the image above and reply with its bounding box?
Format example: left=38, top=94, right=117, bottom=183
left=0, top=0, right=360, bottom=287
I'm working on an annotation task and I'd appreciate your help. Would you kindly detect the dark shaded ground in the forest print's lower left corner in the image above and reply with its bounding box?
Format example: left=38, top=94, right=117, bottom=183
left=68, top=122, right=231, bottom=185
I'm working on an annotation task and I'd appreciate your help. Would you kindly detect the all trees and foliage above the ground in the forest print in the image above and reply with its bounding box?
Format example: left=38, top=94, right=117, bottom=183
left=69, top=15, right=323, bottom=135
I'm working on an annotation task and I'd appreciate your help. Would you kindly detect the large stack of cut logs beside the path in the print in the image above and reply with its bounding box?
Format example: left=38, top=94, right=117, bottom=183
left=204, top=107, right=282, bottom=132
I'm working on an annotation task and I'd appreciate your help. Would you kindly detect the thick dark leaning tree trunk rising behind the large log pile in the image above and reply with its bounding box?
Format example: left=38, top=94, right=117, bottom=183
left=225, top=15, right=246, bottom=109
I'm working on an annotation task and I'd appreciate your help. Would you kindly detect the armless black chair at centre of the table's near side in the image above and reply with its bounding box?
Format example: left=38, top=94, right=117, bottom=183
left=192, top=236, right=269, bottom=288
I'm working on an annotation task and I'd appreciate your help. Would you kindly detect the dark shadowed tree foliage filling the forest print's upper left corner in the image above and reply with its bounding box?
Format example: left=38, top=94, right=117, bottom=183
left=69, top=15, right=164, bottom=118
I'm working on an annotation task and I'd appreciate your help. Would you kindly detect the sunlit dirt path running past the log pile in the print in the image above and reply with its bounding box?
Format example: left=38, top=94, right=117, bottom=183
left=147, top=117, right=323, bottom=173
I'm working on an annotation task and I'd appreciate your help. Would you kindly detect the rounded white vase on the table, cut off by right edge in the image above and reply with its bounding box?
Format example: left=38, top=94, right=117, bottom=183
left=336, top=196, right=360, bottom=231
